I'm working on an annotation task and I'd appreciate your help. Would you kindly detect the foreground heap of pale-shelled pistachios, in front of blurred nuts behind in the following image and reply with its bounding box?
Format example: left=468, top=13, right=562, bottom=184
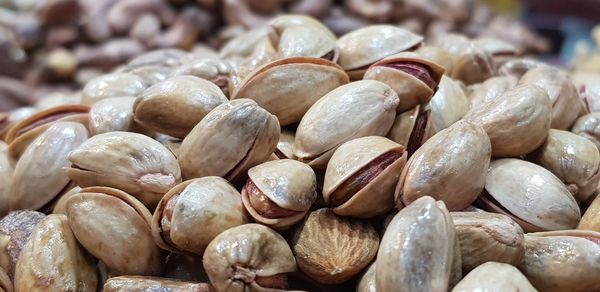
left=0, top=10, right=600, bottom=292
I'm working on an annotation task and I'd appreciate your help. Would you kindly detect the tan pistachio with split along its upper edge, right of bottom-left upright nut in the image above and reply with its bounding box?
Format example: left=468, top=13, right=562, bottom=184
left=66, top=187, right=163, bottom=276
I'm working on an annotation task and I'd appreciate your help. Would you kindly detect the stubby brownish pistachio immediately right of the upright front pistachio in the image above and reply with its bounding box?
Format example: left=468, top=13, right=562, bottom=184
left=450, top=212, right=525, bottom=271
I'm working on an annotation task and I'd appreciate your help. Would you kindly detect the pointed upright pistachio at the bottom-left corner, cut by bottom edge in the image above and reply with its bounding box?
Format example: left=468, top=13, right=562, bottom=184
left=14, top=214, right=98, bottom=292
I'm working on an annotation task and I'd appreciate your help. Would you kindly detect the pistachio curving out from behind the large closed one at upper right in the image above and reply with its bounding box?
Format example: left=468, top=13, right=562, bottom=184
left=519, top=66, right=581, bottom=130
